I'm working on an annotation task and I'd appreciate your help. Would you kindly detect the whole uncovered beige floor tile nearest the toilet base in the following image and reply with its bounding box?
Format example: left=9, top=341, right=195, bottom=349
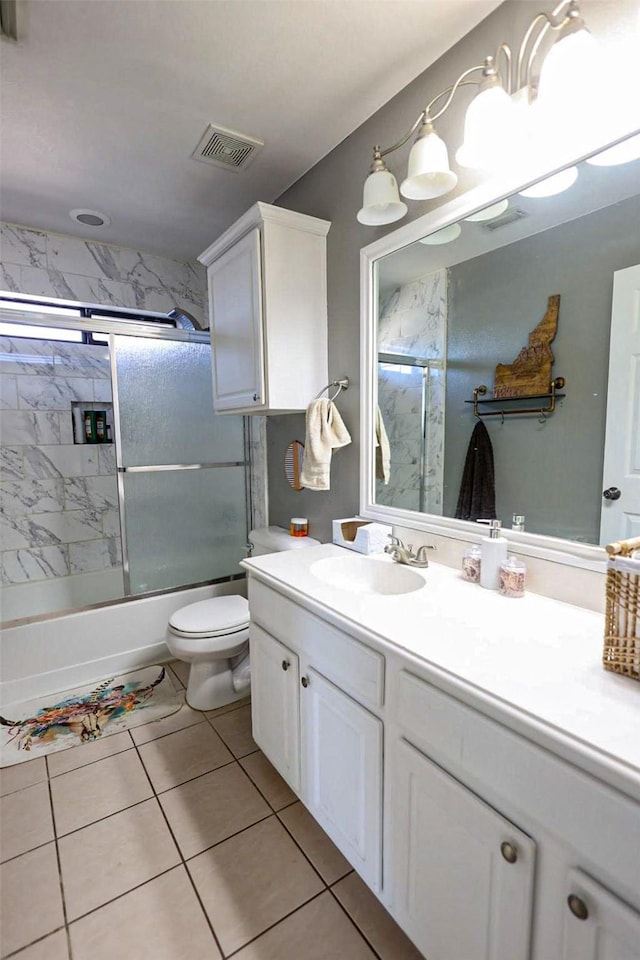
left=138, top=723, right=233, bottom=793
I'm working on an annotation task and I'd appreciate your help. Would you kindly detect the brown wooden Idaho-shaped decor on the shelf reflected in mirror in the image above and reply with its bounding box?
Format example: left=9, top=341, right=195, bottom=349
left=493, top=293, right=560, bottom=399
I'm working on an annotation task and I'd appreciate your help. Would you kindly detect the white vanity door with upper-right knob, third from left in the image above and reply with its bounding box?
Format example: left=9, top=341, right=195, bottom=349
left=390, top=740, right=535, bottom=960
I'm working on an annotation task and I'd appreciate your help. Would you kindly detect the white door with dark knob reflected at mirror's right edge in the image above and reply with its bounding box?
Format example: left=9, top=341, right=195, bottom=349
left=600, top=264, right=640, bottom=546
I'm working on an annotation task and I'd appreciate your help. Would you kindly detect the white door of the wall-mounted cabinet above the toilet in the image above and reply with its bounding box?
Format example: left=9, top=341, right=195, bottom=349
left=208, top=228, right=266, bottom=411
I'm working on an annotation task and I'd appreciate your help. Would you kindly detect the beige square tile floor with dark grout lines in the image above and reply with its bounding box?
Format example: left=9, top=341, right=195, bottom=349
left=0, top=664, right=421, bottom=960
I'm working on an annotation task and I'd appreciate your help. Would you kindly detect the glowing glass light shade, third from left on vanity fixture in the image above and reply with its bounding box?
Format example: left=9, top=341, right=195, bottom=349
left=456, top=85, right=515, bottom=171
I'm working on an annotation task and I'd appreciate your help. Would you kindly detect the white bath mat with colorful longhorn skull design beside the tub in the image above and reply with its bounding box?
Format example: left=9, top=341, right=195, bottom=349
left=0, top=666, right=184, bottom=767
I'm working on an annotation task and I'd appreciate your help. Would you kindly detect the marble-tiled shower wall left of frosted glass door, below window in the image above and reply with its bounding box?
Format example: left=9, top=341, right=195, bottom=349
left=0, top=336, right=122, bottom=589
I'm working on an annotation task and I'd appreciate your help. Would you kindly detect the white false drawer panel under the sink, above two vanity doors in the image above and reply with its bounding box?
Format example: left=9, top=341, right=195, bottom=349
left=249, top=579, right=384, bottom=707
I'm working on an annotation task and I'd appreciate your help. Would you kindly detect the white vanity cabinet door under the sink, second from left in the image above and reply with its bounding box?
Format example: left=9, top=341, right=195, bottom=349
left=300, top=669, right=382, bottom=890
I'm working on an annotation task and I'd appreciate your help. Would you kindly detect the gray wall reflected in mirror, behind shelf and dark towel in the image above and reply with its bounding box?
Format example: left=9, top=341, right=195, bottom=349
left=444, top=197, right=640, bottom=543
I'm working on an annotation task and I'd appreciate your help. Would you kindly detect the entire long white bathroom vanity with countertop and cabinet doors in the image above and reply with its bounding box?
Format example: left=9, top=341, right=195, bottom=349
left=243, top=544, right=640, bottom=960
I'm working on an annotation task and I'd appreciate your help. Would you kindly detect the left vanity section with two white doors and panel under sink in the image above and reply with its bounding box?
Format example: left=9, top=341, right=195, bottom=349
left=249, top=581, right=384, bottom=891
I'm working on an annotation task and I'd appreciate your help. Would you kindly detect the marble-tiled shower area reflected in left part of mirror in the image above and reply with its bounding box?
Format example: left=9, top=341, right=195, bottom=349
left=376, top=270, right=447, bottom=514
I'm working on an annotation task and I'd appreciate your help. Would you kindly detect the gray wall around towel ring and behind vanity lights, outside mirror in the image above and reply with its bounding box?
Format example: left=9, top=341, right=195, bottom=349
left=267, top=0, right=637, bottom=540
